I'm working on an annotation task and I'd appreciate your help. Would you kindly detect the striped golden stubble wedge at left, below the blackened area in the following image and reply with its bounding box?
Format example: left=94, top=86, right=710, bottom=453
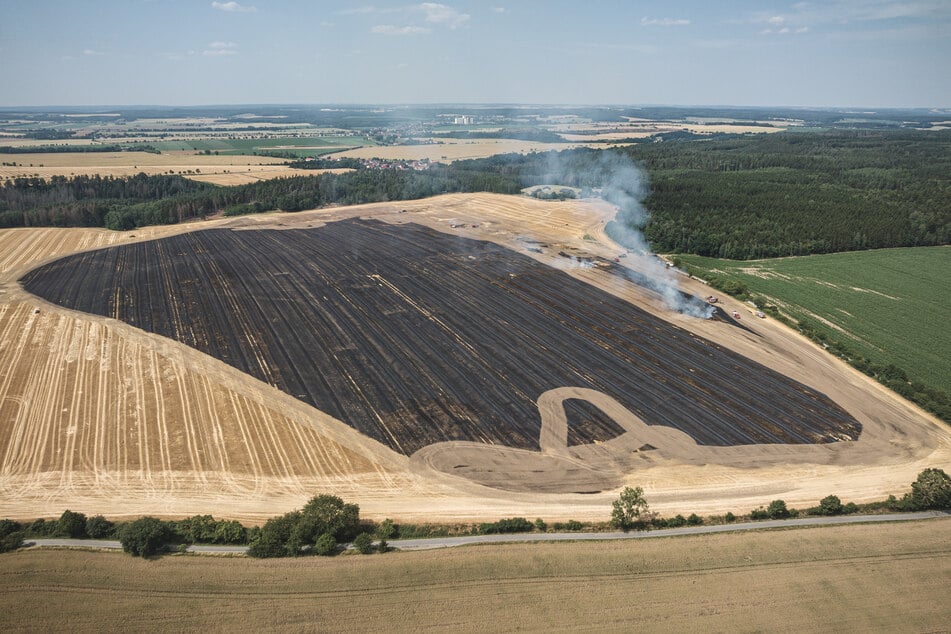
left=0, top=303, right=390, bottom=506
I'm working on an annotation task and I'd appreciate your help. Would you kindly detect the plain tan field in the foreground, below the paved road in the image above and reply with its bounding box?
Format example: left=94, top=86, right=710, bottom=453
left=0, top=518, right=951, bottom=632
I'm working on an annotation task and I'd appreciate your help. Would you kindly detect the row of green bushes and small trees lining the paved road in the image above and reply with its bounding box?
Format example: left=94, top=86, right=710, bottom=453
left=0, top=468, right=951, bottom=558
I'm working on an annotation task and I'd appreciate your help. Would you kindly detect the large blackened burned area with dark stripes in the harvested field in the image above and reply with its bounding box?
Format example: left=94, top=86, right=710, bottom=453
left=21, top=220, right=861, bottom=455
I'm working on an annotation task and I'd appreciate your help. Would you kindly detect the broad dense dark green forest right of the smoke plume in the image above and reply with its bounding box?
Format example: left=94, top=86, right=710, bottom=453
left=623, top=131, right=951, bottom=259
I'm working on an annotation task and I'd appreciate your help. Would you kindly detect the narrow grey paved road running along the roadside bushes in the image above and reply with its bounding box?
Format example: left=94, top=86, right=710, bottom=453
left=20, top=511, right=951, bottom=554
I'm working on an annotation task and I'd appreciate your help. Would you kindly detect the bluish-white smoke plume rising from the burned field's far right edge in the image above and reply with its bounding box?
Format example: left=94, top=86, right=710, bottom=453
left=546, top=150, right=713, bottom=319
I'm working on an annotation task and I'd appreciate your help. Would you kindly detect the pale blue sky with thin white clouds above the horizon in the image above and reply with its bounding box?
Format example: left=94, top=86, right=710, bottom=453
left=0, top=0, right=951, bottom=108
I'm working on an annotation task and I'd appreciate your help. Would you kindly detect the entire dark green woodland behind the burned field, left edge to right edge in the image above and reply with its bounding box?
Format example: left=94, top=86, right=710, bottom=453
left=0, top=130, right=951, bottom=259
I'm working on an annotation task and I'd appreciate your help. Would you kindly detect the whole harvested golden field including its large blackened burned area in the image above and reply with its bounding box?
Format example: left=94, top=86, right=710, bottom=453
left=0, top=194, right=951, bottom=521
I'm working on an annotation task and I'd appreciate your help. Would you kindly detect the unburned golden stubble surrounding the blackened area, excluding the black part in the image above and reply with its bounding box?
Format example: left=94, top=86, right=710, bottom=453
left=0, top=194, right=951, bottom=522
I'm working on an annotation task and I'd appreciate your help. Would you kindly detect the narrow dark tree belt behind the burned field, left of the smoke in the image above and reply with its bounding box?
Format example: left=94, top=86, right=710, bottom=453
left=0, top=164, right=520, bottom=230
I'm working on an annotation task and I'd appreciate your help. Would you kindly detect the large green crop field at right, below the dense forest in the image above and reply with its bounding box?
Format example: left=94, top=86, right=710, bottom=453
left=679, top=247, right=951, bottom=392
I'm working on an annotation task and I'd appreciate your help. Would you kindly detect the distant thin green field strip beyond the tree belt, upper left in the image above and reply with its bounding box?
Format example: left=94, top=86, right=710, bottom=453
left=150, top=136, right=372, bottom=157
